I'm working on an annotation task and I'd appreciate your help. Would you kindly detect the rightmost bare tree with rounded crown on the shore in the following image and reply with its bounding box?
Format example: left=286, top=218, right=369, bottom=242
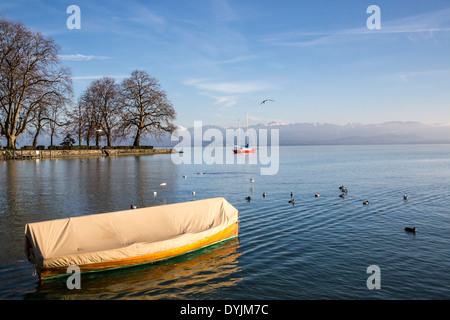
left=122, top=70, right=176, bottom=146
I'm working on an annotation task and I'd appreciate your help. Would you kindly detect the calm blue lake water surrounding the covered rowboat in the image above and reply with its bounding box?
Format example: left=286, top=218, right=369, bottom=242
left=0, top=145, right=450, bottom=300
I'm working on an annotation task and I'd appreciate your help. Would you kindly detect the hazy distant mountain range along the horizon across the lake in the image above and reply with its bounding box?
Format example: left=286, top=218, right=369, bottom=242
left=146, top=121, right=450, bottom=147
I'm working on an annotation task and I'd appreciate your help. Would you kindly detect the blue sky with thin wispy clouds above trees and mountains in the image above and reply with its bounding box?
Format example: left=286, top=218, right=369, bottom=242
left=0, top=0, right=450, bottom=127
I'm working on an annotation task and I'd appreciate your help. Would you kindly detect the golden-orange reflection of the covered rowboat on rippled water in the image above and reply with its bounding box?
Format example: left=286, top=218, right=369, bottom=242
left=25, top=238, right=242, bottom=299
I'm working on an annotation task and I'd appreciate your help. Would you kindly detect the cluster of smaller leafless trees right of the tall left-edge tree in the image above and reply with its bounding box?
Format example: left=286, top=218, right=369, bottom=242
left=68, top=70, right=175, bottom=146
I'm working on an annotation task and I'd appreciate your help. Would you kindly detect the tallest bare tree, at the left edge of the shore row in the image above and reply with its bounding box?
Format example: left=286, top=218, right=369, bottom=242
left=0, top=17, right=72, bottom=148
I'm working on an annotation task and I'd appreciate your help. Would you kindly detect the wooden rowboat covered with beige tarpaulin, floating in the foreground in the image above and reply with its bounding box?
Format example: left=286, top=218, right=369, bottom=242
left=25, top=197, right=239, bottom=279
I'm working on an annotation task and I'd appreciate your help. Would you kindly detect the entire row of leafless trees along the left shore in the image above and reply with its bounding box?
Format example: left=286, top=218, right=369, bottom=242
left=0, top=17, right=175, bottom=148
